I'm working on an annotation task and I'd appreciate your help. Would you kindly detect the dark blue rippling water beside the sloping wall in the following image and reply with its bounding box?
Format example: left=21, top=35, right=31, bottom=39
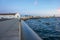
left=25, top=18, right=60, bottom=40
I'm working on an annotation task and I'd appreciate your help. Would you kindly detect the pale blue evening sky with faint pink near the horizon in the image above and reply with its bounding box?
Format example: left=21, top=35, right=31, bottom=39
left=0, top=0, right=60, bottom=16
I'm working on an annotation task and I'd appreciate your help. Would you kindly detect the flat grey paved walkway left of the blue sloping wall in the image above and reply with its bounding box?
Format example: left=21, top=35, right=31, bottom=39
left=0, top=19, right=21, bottom=40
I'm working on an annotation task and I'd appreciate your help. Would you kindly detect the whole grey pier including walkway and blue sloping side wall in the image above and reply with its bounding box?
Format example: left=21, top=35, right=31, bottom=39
left=0, top=19, right=42, bottom=40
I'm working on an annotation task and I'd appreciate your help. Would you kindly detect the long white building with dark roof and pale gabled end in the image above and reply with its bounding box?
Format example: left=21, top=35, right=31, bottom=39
left=0, top=13, right=20, bottom=19
